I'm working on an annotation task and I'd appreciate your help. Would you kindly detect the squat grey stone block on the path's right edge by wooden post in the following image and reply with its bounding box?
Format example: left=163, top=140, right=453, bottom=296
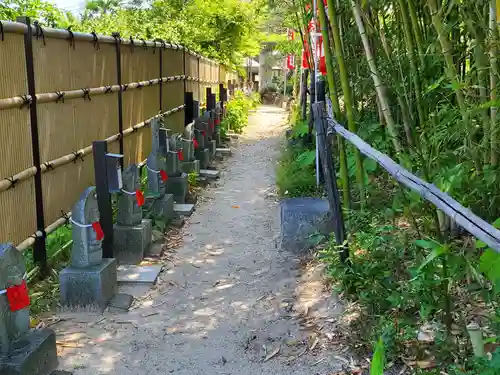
left=280, top=198, right=334, bottom=253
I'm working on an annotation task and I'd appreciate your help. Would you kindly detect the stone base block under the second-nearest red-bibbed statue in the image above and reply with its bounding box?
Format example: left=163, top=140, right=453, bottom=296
left=59, top=258, right=118, bottom=311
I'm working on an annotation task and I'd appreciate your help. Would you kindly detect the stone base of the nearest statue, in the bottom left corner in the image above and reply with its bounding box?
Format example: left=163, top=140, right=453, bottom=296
left=0, top=328, right=57, bottom=375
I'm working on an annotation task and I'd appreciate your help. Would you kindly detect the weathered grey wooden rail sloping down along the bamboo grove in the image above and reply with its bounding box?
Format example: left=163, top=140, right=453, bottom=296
left=320, top=110, right=500, bottom=253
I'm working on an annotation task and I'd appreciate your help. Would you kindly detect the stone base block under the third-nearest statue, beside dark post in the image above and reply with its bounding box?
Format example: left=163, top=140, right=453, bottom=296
left=113, top=220, right=151, bottom=264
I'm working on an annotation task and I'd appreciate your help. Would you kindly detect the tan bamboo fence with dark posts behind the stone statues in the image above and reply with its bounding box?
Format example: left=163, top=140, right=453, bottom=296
left=0, top=17, right=237, bottom=260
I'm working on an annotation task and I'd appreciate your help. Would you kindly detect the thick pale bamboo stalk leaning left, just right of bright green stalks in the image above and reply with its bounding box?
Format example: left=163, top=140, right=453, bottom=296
left=351, top=0, right=402, bottom=153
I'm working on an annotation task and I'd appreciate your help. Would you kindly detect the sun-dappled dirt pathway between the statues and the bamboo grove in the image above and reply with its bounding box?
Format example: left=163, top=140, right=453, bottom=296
left=53, top=107, right=339, bottom=375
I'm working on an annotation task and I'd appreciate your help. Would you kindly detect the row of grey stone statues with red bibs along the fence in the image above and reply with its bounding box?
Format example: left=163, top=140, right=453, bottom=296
left=0, top=106, right=223, bottom=375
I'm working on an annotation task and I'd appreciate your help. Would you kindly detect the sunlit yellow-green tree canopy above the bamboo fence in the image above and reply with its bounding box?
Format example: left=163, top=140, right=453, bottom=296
left=0, top=0, right=268, bottom=66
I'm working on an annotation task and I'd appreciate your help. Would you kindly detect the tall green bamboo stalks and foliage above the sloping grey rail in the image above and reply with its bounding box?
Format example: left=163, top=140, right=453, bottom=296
left=294, top=0, right=500, bottom=223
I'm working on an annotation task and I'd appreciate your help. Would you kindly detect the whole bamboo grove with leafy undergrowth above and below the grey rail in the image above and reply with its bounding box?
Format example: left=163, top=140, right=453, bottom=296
left=276, top=0, right=500, bottom=375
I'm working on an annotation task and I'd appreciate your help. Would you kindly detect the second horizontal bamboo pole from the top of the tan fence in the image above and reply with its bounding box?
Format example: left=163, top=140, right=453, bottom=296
left=0, top=75, right=185, bottom=110
